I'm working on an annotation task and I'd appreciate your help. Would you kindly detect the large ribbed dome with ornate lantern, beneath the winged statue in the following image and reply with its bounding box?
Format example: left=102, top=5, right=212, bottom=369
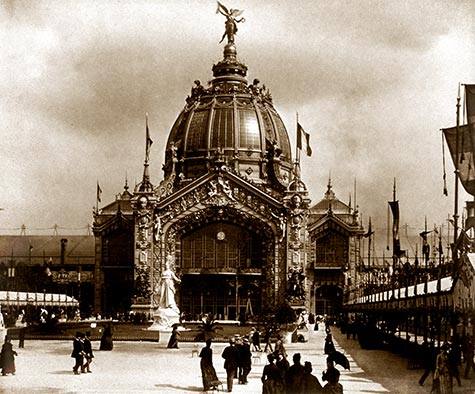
left=164, top=43, right=292, bottom=188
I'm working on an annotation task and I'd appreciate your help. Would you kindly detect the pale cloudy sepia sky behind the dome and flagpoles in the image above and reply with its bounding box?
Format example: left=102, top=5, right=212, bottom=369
left=0, top=0, right=475, bottom=255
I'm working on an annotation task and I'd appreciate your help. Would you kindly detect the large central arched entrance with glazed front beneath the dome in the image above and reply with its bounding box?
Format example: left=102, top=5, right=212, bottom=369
left=179, top=221, right=266, bottom=320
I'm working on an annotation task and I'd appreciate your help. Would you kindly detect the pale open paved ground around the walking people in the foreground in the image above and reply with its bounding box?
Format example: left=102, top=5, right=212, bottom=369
left=0, top=329, right=475, bottom=394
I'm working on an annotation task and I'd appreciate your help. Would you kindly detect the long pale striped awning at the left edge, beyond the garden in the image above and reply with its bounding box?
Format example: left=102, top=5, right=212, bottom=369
left=0, top=291, right=79, bottom=307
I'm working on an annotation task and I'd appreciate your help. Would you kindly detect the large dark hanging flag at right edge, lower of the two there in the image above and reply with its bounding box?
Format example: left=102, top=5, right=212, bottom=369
left=442, top=125, right=475, bottom=196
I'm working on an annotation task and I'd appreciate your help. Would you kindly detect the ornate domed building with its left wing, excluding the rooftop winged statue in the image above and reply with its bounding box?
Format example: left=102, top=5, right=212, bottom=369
left=94, top=27, right=310, bottom=320
